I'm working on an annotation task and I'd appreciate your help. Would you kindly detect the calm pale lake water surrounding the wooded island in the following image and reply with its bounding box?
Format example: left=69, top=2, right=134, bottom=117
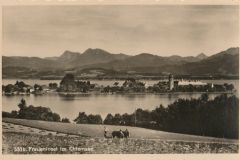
left=2, top=79, right=239, bottom=120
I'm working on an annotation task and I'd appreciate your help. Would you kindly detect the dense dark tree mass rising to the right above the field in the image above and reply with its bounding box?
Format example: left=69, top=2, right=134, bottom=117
left=104, top=94, right=239, bottom=139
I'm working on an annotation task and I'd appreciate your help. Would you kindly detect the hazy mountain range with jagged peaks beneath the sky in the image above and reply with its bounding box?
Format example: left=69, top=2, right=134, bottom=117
left=2, top=47, right=239, bottom=77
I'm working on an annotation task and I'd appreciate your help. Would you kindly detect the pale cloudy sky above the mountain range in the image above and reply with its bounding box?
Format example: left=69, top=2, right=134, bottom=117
left=2, top=5, right=239, bottom=57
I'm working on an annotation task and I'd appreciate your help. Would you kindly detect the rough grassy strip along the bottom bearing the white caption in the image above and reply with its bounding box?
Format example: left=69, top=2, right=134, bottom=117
left=3, top=132, right=238, bottom=154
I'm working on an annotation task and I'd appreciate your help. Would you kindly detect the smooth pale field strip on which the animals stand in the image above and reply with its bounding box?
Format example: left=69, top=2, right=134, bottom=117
left=3, top=118, right=238, bottom=143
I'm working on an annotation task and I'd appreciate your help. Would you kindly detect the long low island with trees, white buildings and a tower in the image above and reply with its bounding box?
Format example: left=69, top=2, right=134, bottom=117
left=2, top=73, right=235, bottom=95
